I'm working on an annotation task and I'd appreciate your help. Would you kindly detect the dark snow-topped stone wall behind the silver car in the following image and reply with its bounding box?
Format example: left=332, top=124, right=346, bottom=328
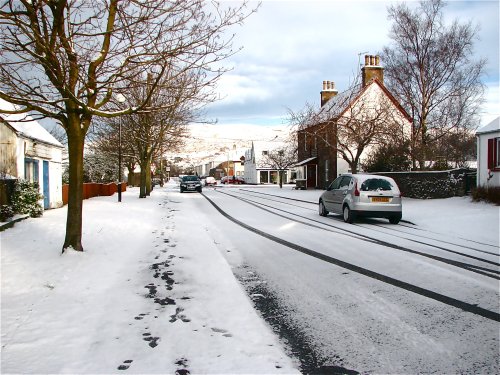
left=377, top=168, right=475, bottom=199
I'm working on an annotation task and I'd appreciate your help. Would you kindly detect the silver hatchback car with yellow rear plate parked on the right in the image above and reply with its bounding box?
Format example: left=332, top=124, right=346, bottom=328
left=319, top=174, right=403, bottom=224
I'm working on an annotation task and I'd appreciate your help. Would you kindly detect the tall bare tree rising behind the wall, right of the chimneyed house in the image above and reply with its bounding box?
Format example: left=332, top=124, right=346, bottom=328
left=383, top=0, right=486, bottom=168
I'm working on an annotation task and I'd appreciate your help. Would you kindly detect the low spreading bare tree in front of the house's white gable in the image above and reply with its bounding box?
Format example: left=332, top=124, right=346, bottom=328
left=289, top=82, right=407, bottom=173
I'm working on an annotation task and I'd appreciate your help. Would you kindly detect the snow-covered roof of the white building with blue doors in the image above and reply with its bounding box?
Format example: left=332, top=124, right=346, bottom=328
left=0, top=99, right=64, bottom=147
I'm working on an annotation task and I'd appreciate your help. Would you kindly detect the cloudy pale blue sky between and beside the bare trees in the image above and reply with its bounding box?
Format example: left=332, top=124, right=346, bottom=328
left=204, top=0, right=500, bottom=131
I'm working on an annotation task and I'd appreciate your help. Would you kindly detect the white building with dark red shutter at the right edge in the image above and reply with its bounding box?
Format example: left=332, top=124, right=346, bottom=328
left=476, top=117, right=500, bottom=187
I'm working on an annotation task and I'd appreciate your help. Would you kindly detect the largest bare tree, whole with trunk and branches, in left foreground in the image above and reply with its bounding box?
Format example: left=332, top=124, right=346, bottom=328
left=0, top=0, right=256, bottom=252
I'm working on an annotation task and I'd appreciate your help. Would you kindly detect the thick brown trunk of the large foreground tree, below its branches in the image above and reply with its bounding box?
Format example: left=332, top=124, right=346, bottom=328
left=62, top=131, right=85, bottom=253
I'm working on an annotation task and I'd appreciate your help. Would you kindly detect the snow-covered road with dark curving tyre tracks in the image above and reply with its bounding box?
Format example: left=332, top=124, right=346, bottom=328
left=200, top=187, right=499, bottom=373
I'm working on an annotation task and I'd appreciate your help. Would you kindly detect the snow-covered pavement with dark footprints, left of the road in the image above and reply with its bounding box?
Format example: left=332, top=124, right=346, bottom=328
left=0, top=182, right=297, bottom=374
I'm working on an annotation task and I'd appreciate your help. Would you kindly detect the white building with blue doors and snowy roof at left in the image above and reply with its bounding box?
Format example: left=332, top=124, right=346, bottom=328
left=0, top=99, right=64, bottom=209
